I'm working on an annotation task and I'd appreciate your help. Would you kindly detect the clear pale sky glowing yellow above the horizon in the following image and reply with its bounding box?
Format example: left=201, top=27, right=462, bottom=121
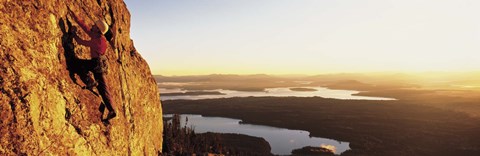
left=125, top=0, right=480, bottom=75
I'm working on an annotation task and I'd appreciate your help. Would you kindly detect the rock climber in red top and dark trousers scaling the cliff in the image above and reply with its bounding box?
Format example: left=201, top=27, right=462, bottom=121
left=70, top=11, right=117, bottom=123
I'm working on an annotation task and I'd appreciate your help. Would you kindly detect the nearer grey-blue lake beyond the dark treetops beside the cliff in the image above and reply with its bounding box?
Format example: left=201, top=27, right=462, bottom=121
left=164, top=114, right=350, bottom=155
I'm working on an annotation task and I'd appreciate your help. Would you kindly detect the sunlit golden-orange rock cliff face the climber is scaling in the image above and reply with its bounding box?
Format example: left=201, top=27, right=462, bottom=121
left=0, top=0, right=163, bottom=155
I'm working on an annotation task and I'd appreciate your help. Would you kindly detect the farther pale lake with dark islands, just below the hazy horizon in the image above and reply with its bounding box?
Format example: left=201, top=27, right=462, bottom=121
left=160, top=87, right=396, bottom=100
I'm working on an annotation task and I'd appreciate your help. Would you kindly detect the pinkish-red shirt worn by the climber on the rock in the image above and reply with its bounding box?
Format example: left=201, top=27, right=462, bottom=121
left=73, top=15, right=107, bottom=58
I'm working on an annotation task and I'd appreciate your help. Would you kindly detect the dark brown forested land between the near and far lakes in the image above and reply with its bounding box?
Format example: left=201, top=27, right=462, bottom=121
left=162, top=97, right=480, bottom=155
